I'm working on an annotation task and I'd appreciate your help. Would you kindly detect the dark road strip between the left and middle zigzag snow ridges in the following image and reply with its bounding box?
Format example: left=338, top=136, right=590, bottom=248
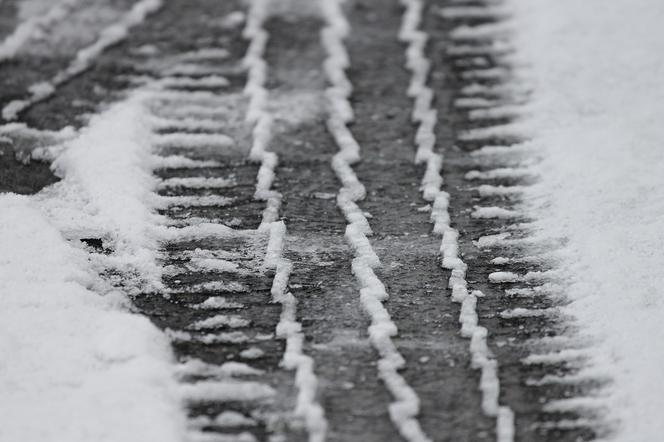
left=266, top=7, right=399, bottom=441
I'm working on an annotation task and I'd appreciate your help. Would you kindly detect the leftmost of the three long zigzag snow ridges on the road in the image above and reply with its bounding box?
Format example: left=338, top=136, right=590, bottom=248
left=243, top=0, right=327, bottom=442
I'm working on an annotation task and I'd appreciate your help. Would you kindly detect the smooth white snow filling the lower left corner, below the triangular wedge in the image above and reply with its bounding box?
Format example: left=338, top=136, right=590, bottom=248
left=0, top=194, right=185, bottom=442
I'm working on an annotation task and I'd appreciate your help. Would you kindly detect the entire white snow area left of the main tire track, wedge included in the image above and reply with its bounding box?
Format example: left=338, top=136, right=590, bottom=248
left=0, top=94, right=186, bottom=442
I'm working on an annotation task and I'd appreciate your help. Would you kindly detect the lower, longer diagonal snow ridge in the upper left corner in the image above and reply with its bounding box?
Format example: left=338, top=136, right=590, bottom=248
left=2, top=0, right=162, bottom=120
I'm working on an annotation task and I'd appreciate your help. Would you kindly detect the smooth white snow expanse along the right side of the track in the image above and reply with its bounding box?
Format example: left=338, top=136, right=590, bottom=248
left=510, top=0, right=664, bottom=436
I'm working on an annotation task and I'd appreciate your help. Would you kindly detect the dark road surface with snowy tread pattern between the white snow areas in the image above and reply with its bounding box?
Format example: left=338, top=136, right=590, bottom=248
left=0, top=0, right=601, bottom=442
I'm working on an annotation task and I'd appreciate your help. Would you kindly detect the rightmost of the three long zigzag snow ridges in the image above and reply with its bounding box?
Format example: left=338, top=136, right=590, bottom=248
left=399, top=0, right=514, bottom=442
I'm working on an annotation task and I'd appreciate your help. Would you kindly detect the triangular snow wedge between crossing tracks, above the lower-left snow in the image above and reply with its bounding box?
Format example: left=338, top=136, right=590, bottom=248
left=36, top=94, right=161, bottom=291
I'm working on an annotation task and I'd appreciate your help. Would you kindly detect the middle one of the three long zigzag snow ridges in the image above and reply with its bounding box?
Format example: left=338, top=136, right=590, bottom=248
left=320, top=0, right=431, bottom=442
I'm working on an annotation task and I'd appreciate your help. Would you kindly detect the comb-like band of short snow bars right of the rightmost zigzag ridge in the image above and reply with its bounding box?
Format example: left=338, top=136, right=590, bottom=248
left=426, top=1, right=604, bottom=441
